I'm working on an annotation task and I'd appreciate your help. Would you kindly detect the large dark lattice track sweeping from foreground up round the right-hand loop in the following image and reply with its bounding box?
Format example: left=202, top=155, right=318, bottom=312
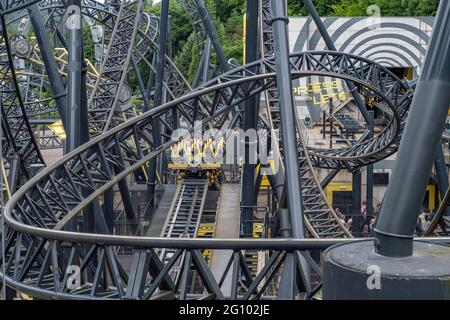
left=0, top=0, right=412, bottom=299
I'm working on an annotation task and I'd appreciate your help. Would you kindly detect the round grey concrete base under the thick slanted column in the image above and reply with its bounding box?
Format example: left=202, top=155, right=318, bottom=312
left=323, top=241, right=450, bottom=300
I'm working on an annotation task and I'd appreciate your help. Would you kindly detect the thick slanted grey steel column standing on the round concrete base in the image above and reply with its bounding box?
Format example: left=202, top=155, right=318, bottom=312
left=375, top=1, right=450, bottom=257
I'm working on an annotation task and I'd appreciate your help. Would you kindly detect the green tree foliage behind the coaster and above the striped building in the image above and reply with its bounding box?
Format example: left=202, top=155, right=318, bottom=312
left=146, top=0, right=439, bottom=81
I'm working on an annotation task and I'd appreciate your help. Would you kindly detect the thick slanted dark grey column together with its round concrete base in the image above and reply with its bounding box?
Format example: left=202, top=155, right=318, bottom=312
left=323, top=1, right=450, bottom=299
